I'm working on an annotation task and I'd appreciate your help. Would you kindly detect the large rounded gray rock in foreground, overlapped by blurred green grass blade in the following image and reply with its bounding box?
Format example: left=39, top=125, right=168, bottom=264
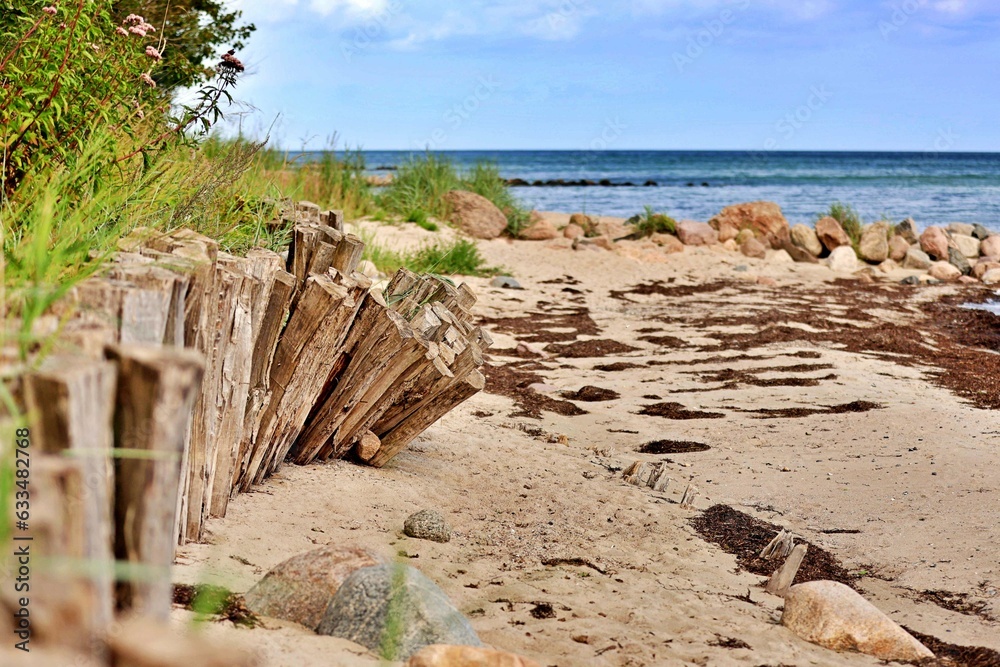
left=316, top=565, right=482, bottom=660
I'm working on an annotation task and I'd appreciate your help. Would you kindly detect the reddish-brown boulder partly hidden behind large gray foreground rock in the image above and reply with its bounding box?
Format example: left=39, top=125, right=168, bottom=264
left=245, top=546, right=378, bottom=630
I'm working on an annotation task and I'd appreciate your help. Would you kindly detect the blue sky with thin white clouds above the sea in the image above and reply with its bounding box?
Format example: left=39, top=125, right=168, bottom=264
left=225, top=0, right=1000, bottom=151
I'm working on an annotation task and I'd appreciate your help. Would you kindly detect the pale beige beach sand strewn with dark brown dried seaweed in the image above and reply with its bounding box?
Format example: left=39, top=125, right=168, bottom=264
left=176, top=217, right=1000, bottom=667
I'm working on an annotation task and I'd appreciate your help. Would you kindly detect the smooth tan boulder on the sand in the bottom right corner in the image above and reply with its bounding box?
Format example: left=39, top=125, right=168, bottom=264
left=781, top=581, right=934, bottom=662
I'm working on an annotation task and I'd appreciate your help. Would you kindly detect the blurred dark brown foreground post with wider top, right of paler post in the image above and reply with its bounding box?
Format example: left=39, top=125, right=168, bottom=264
left=108, top=346, right=204, bottom=620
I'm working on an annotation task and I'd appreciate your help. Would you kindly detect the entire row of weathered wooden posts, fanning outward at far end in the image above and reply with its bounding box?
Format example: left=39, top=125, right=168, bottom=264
left=0, top=206, right=492, bottom=656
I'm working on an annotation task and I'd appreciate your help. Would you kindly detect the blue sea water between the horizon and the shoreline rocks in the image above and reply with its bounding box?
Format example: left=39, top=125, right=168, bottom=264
left=298, top=151, right=1000, bottom=228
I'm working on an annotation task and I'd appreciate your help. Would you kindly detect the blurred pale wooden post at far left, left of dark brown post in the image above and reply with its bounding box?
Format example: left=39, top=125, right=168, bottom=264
left=24, top=357, right=116, bottom=648
